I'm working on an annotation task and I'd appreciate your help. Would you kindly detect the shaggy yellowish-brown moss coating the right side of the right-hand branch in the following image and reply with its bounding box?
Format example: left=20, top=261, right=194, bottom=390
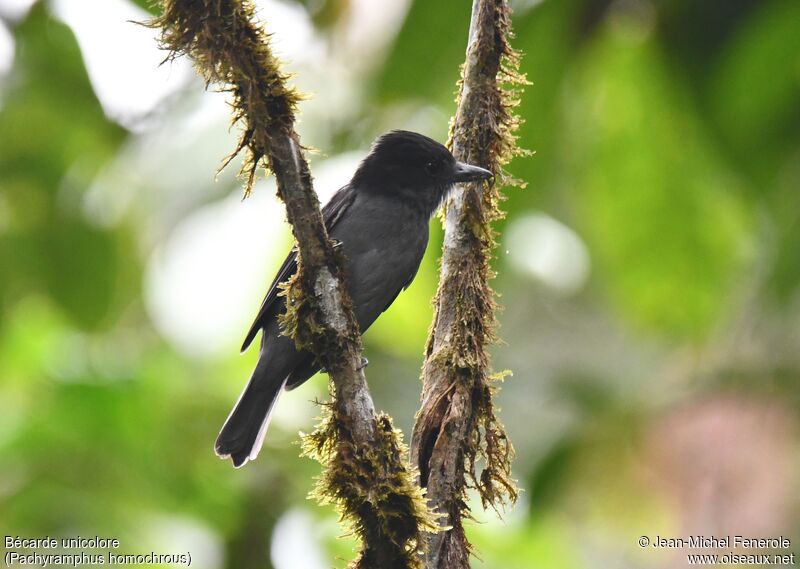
left=440, top=1, right=531, bottom=509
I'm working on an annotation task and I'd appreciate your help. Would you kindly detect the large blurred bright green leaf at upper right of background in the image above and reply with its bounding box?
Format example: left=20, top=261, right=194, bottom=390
left=565, top=20, right=750, bottom=340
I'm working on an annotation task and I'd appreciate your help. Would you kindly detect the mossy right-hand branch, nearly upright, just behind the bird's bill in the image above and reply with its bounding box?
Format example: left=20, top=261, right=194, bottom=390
left=411, top=0, right=527, bottom=569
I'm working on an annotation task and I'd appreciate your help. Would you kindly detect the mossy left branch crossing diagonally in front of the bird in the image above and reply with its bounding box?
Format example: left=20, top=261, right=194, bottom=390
left=150, top=0, right=435, bottom=569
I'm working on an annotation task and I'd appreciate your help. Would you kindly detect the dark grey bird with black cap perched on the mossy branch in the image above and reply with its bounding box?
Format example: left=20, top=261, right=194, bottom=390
left=215, top=131, right=492, bottom=467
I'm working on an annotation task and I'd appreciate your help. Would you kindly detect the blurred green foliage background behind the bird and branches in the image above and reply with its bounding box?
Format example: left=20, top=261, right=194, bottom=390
left=0, top=0, right=800, bottom=569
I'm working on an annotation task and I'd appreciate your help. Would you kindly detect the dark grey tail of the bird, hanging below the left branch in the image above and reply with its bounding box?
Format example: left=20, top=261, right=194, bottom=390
left=214, top=358, right=286, bottom=468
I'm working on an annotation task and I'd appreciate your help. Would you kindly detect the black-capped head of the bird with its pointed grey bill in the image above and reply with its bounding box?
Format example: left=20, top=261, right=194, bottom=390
left=353, top=130, right=492, bottom=213
